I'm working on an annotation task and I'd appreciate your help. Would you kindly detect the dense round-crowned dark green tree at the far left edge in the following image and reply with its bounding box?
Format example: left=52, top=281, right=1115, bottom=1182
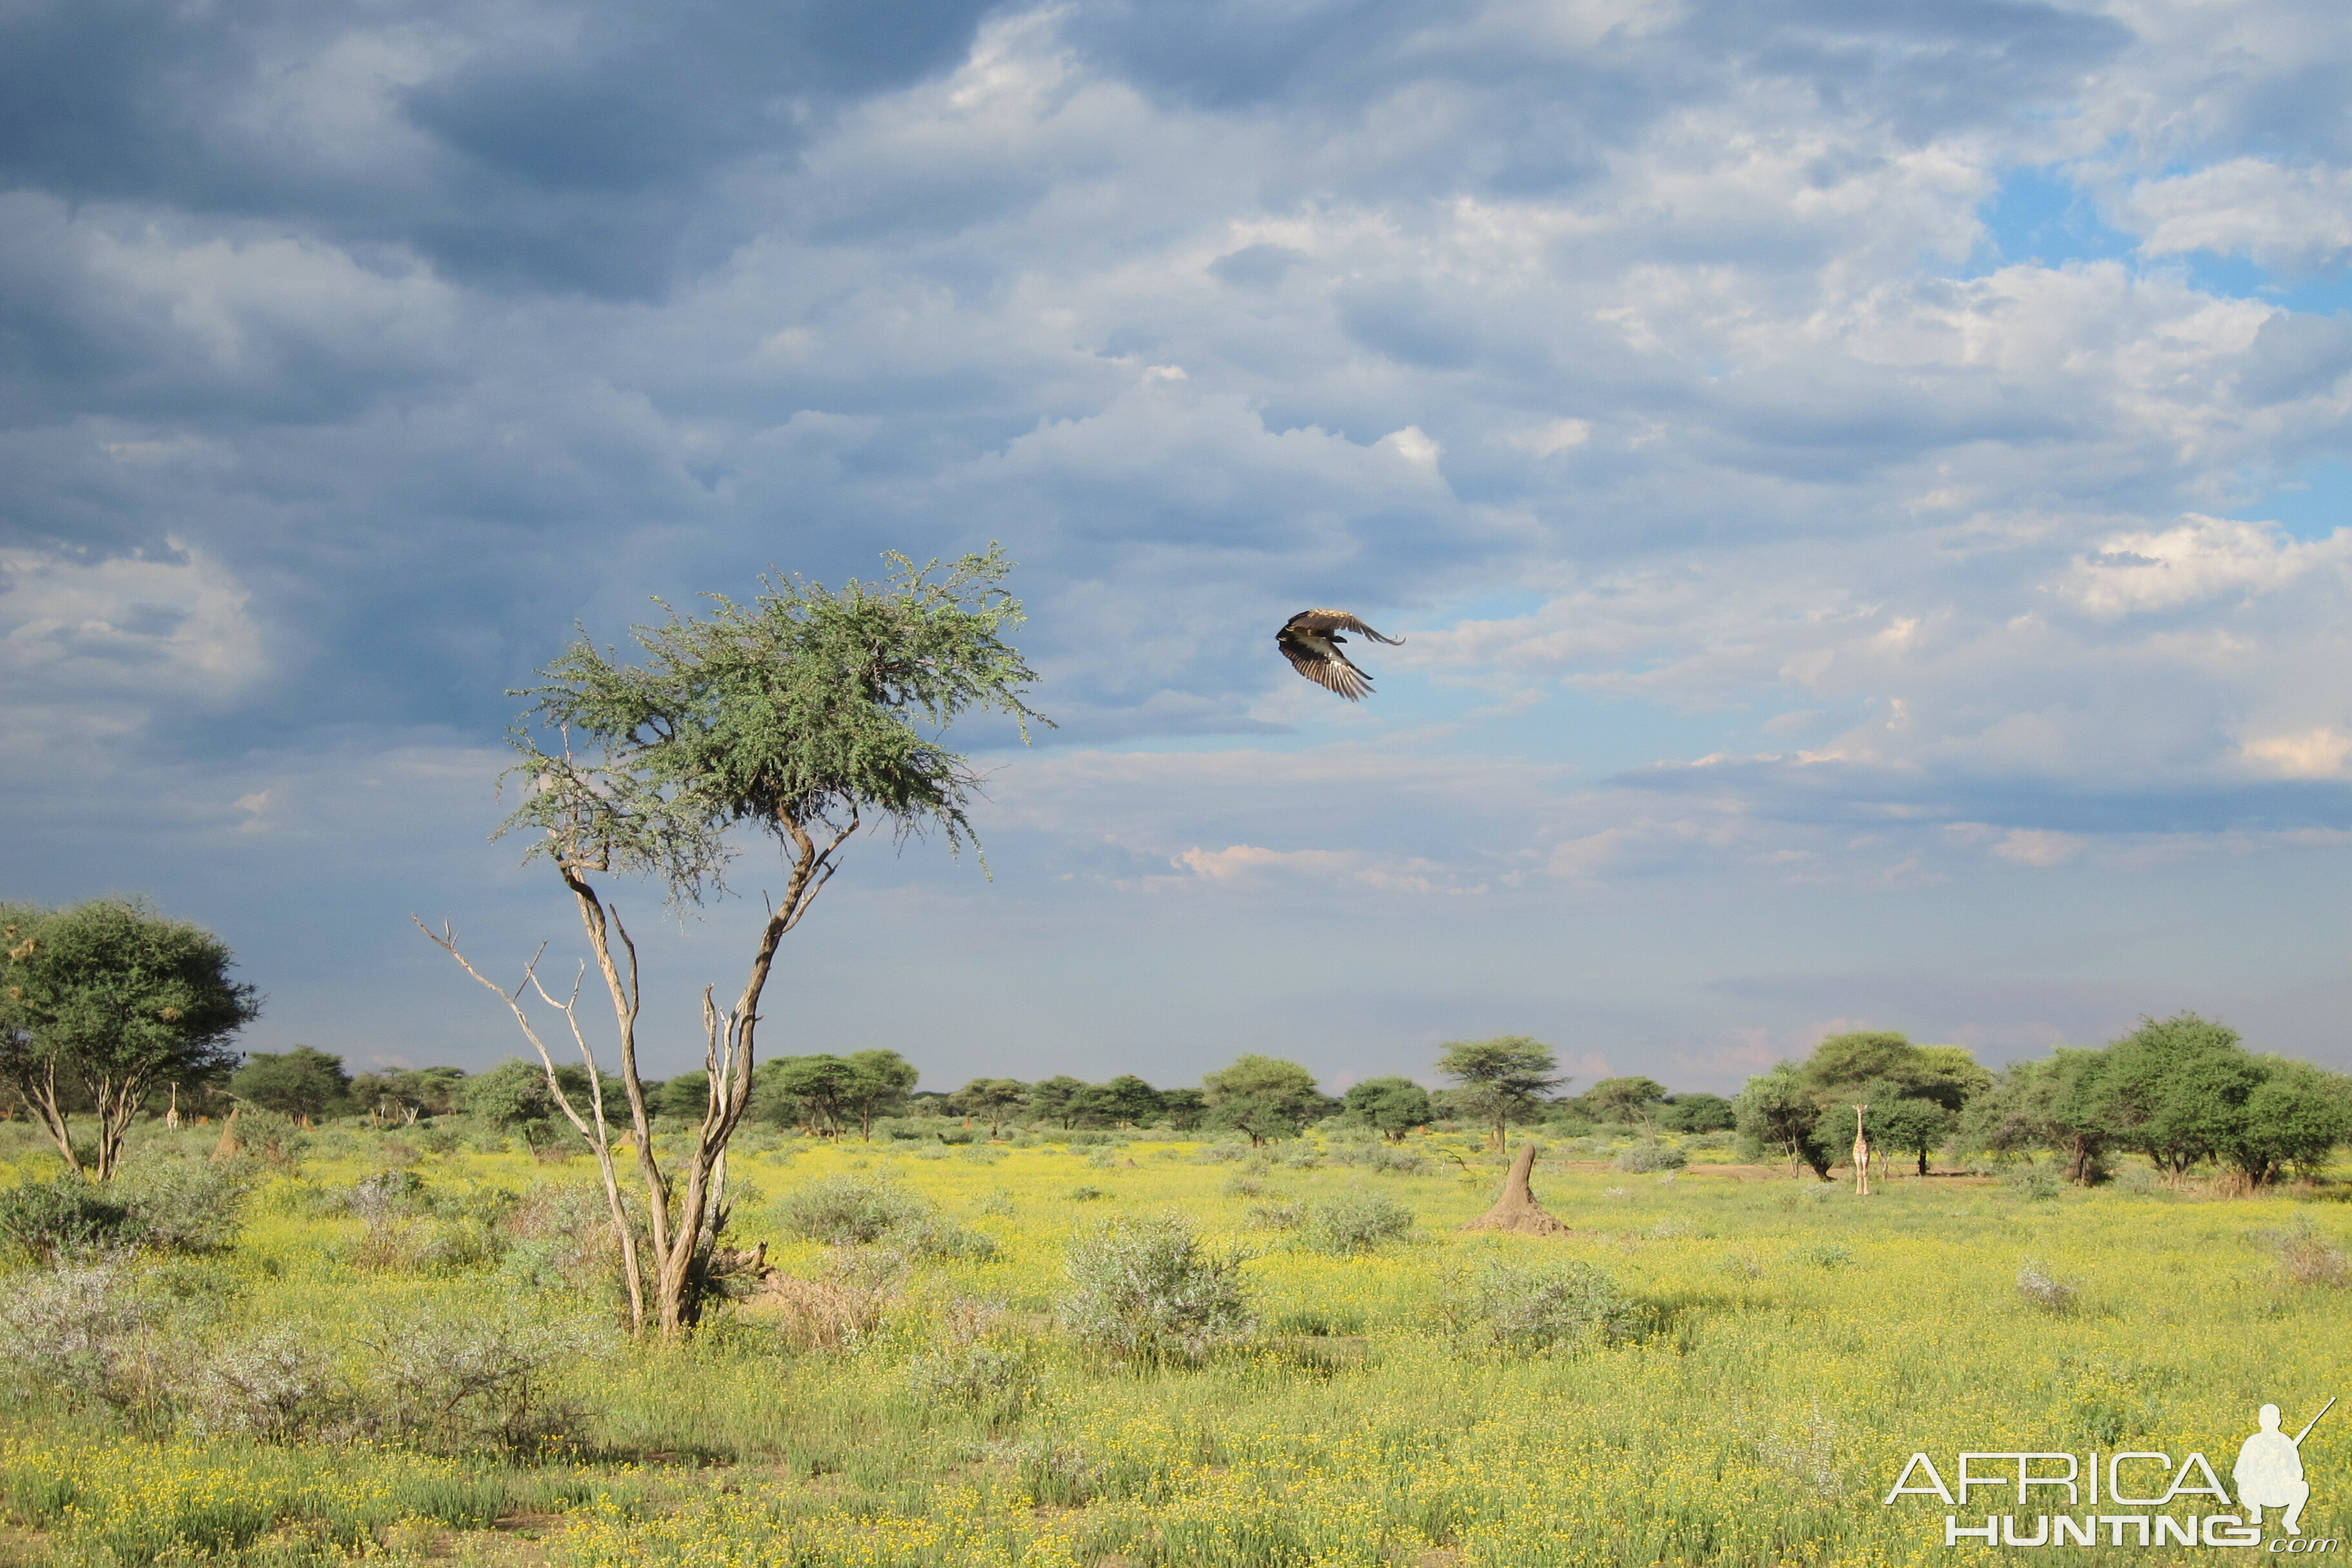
left=0, top=898, right=261, bottom=1180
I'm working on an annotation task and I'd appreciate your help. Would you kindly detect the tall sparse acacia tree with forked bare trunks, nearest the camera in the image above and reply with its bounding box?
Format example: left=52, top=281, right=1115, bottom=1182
left=435, top=548, right=1037, bottom=1338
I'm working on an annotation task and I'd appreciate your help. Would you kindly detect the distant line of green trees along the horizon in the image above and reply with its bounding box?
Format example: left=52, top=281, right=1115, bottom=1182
left=0, top=898, right=2352, bottom=1187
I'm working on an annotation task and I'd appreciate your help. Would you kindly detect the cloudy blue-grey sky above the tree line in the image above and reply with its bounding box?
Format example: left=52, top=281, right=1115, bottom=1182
left=0, top=0, right=2352, bottom=1091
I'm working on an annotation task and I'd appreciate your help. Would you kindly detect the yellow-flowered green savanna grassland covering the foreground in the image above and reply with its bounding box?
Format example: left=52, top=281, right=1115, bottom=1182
left=0, top=1126, right=2352, bottom=1568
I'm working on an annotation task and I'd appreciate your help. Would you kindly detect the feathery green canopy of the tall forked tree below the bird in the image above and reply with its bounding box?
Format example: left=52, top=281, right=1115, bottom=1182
left=505, top=548, right=1037, bottom=903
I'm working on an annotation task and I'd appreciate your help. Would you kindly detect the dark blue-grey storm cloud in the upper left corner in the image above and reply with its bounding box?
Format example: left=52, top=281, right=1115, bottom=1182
left=0, top=0, right=988, bottom=299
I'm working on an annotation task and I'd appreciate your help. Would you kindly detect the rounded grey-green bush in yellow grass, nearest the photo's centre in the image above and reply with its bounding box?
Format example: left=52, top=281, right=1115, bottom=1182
left=1059, top=1213, right=1256, bottom=1366
